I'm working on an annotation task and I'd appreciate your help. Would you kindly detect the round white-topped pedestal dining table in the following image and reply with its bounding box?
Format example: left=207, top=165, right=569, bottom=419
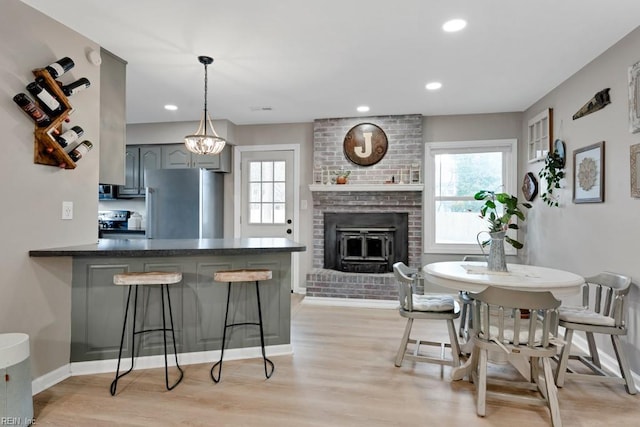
left=422, top=261, right=585, bottom=380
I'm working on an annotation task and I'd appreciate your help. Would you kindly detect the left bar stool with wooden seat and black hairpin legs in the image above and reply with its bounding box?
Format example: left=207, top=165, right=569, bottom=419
left=110, top=271, right=184, bottom=396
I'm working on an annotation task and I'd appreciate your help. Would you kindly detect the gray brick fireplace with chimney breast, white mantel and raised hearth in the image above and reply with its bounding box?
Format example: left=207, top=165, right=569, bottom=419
left=306, top=115, right=423, bottom=300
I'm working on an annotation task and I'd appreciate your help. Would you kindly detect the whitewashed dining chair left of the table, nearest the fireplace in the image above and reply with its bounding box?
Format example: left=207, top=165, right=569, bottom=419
left=393, top=262, right=460, bottom=367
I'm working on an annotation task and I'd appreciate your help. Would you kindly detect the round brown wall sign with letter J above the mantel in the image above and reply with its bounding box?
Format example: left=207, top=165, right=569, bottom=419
left=343, top=123, right=389, bottom=166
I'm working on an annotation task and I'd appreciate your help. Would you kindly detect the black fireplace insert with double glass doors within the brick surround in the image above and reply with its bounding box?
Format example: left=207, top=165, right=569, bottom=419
left=324, top=212, right=409, bottom=273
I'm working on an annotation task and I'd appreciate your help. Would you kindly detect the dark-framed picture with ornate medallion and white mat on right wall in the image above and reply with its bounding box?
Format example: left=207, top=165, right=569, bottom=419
left=573, top=141, right=604, bottom=203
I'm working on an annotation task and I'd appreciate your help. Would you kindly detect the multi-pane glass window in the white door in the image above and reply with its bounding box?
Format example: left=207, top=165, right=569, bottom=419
left=249, top=161, right=286, bottom=224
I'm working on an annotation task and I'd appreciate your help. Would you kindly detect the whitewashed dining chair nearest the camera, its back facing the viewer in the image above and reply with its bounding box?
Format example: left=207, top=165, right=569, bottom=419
left=470, top=287, right=562, bottom=427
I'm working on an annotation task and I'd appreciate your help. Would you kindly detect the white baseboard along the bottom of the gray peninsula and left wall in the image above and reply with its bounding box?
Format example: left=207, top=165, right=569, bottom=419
left=31, top=344, right=293, bottom=396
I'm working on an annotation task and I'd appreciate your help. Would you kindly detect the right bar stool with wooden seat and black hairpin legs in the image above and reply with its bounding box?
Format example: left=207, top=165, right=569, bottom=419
left=211, top=269, right=275, bottom=383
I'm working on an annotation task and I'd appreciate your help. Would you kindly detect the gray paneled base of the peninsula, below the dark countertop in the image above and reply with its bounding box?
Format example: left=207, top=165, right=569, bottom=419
left=71, top=253, right=291, bottom=362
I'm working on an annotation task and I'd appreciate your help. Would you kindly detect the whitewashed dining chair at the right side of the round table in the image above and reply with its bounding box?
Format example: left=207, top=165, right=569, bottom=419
left=556, top=272, right=636, bottom=394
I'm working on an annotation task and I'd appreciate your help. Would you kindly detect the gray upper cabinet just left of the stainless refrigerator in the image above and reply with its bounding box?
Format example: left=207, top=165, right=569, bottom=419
left=118, top=145, right=162, bottom=197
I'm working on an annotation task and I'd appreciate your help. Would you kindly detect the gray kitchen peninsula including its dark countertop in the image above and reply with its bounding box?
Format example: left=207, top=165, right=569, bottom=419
left=29, top=238, right=306, bottom=362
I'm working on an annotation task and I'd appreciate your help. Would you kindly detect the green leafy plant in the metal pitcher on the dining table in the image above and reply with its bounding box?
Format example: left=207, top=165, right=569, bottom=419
left=473, top=190, right=531, bottom=249
